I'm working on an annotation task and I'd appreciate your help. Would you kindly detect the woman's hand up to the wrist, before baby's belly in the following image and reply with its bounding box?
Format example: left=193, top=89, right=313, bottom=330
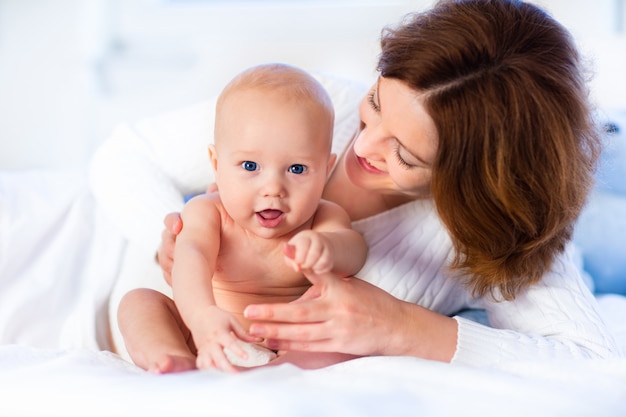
left=244, top=271, right=402, bottom=355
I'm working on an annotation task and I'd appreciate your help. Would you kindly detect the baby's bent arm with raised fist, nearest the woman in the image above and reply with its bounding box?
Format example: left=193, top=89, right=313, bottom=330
left=285, top=201, right=367, bottom=276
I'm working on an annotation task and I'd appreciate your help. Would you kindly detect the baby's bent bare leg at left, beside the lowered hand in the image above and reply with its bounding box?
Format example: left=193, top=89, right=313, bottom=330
left=118, top=288, right=196, bottom=373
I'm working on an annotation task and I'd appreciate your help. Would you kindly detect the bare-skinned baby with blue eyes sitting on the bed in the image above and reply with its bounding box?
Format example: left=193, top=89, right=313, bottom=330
left=118, top=64, right=367, bottom=373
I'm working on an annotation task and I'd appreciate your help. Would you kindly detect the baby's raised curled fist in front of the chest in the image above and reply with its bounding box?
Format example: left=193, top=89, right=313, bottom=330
left=283, top=230, right=335, bottom=274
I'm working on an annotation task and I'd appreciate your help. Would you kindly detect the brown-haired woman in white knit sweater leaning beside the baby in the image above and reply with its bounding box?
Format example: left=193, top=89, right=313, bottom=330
left=116, top=0, right=617, bottom=366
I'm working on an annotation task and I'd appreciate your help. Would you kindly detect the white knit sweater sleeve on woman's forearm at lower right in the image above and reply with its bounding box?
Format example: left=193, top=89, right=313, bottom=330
left=452, top=244, right=619, bottom=367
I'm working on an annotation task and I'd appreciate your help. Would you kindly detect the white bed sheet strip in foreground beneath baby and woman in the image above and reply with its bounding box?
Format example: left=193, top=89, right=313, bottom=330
left=0, top=340, right=626, bottom=417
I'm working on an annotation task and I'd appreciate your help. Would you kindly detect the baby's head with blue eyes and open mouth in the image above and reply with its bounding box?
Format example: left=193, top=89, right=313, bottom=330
left=209, top=64, right=334, bottom=237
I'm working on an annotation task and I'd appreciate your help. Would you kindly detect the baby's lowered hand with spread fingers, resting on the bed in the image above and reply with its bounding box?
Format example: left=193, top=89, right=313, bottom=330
left=192, top=306, right=257, bottom=372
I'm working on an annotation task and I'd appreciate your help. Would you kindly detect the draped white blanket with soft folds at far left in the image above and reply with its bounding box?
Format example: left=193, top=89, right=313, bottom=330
left=0, top=171, right=126, bottom=349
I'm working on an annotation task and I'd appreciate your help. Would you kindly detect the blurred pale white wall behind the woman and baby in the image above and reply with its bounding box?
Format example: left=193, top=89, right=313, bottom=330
left=0, top=0, right=626, bottom=170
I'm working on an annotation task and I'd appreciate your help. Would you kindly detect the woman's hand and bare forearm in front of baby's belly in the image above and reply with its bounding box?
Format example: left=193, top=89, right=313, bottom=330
left=244, top=272, right=457, bottom=362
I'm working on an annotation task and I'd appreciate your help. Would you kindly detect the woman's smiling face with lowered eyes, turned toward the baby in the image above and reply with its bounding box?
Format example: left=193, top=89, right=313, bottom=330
left=345, top=77, right=437, bottom=198
